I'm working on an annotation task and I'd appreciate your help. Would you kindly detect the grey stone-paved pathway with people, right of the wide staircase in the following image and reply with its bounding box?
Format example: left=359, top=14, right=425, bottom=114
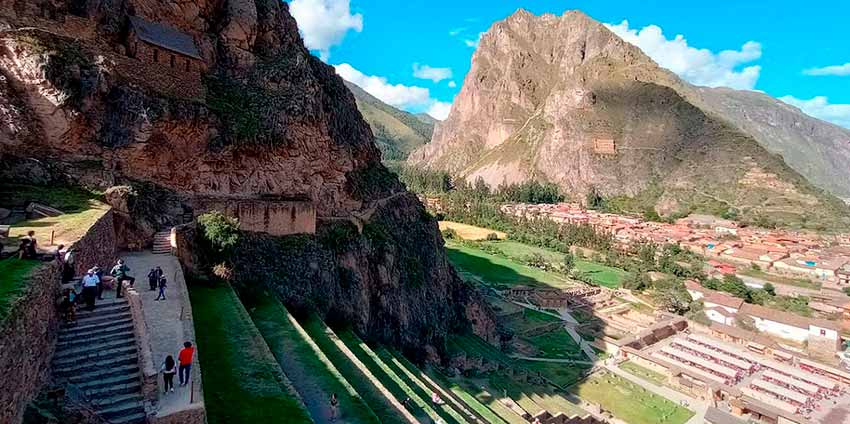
left=122, top=251, right=203, bottom=417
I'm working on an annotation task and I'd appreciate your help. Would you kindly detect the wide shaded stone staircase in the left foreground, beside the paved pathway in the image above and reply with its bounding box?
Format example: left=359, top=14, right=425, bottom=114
left=53, top=299, right=146, bottom=424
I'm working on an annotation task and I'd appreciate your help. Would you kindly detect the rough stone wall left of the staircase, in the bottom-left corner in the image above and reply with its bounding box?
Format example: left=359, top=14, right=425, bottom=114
left=0, top=262, right=60, bottom=423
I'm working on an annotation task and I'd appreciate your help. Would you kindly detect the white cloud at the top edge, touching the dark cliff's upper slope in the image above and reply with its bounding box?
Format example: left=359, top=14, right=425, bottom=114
left=289, top=0, right=363, bottom=61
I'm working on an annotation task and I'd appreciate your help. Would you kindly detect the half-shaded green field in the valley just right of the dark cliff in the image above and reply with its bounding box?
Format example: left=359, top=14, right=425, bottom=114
left=446, top=241, right=575, bottom=288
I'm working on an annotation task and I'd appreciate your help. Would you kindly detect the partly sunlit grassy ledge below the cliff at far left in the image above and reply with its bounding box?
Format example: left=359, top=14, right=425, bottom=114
left=0, top=185, right=109, bottom=249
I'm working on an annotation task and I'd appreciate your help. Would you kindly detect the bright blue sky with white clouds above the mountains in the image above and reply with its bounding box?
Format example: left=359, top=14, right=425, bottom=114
left=290, top=0, right=850, bottom=127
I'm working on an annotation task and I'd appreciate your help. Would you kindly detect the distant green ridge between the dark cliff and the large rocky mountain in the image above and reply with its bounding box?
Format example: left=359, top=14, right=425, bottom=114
left=345, top=81, right=436, bottom=160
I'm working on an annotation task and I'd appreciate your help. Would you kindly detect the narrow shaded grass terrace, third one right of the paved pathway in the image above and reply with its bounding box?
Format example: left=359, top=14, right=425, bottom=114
left=300, top=317, right=414, bottom=424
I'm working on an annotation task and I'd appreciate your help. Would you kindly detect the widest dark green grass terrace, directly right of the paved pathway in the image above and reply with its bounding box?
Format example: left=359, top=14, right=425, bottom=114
left=189, top=284, right=312, bottom=424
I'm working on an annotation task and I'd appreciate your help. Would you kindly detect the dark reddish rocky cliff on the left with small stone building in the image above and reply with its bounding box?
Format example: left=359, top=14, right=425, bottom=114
left=0, top=0, right=493, bottom=355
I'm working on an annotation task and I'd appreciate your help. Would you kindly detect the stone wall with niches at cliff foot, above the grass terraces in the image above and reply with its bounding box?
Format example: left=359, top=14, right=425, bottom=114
left=192, top=196, right=316, bottom=236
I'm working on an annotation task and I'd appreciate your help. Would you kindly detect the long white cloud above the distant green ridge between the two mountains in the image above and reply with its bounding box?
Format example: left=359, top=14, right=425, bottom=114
left=334, top=63, right=452, bottom=120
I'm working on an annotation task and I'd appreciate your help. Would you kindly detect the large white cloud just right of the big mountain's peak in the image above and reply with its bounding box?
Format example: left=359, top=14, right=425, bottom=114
left=605, top=21, right=761, bottom=90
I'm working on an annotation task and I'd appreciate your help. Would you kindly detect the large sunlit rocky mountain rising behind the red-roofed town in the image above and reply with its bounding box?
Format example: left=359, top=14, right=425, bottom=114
left=409, top=10, right=848, bottom=228
